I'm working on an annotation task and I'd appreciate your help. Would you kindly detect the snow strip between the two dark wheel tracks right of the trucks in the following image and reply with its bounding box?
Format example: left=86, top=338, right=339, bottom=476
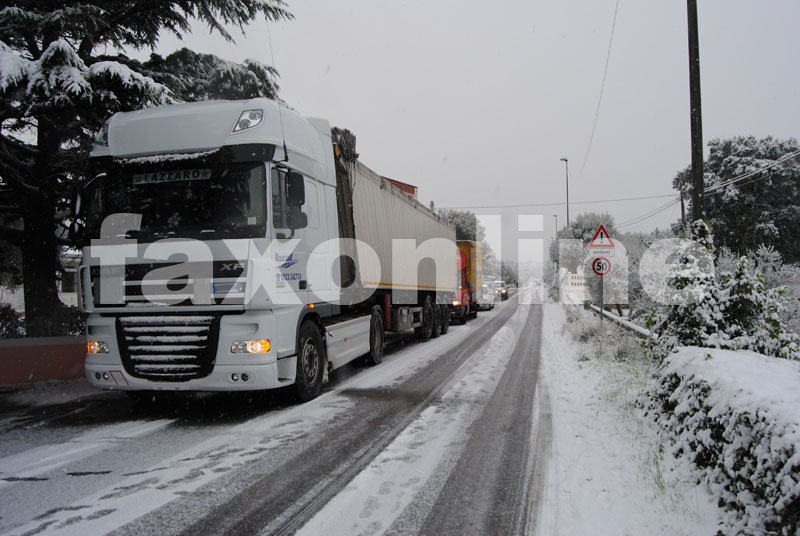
left=297, top=306, right=528, bottom=536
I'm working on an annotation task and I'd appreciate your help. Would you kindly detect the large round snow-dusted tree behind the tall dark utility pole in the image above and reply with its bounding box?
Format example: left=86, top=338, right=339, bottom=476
left=673, top=136, right=800, bottom=263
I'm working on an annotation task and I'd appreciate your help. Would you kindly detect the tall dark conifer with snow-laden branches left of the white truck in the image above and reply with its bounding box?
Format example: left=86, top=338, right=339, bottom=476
left=0, top=0, right=290, bottom=336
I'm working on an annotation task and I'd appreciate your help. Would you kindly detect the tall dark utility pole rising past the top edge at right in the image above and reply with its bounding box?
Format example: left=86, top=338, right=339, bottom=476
left=686, top=0, right=705, bottom=221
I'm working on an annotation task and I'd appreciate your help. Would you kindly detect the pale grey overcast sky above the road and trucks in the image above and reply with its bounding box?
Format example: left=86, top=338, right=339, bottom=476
left=152, top=0, right=800, bottom=264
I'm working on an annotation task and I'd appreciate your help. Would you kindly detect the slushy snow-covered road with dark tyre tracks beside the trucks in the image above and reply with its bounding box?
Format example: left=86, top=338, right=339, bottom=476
left=0, top=299, right=552, bottom=534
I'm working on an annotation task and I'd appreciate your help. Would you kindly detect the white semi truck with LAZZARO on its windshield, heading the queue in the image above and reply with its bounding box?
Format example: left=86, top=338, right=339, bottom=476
left=78, top=98, right=457, bottom=401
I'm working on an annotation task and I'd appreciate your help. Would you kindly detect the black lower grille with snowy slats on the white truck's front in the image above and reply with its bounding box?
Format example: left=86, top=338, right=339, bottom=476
left=117, top=314, right=220, bottom=382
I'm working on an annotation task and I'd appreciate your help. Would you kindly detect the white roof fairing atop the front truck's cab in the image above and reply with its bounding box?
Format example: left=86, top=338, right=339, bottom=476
left=92, top=98, right=335, bottom=184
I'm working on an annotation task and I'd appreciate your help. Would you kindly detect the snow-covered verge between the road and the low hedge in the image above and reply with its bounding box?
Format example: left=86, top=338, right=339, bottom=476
left=537, top=304, right=720, bottom=536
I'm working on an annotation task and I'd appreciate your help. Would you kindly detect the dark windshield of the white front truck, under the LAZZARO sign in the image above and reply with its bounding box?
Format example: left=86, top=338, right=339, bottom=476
left=86, top=162, right=267, bottom=239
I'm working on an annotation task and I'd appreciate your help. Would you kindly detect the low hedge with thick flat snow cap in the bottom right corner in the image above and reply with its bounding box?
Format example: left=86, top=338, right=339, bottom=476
left=643, top=347, right=800, bottom=536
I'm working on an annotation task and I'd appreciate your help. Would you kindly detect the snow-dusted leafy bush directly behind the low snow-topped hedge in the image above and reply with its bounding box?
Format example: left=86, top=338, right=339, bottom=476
left=648, top=221, right=800, bottom=359
